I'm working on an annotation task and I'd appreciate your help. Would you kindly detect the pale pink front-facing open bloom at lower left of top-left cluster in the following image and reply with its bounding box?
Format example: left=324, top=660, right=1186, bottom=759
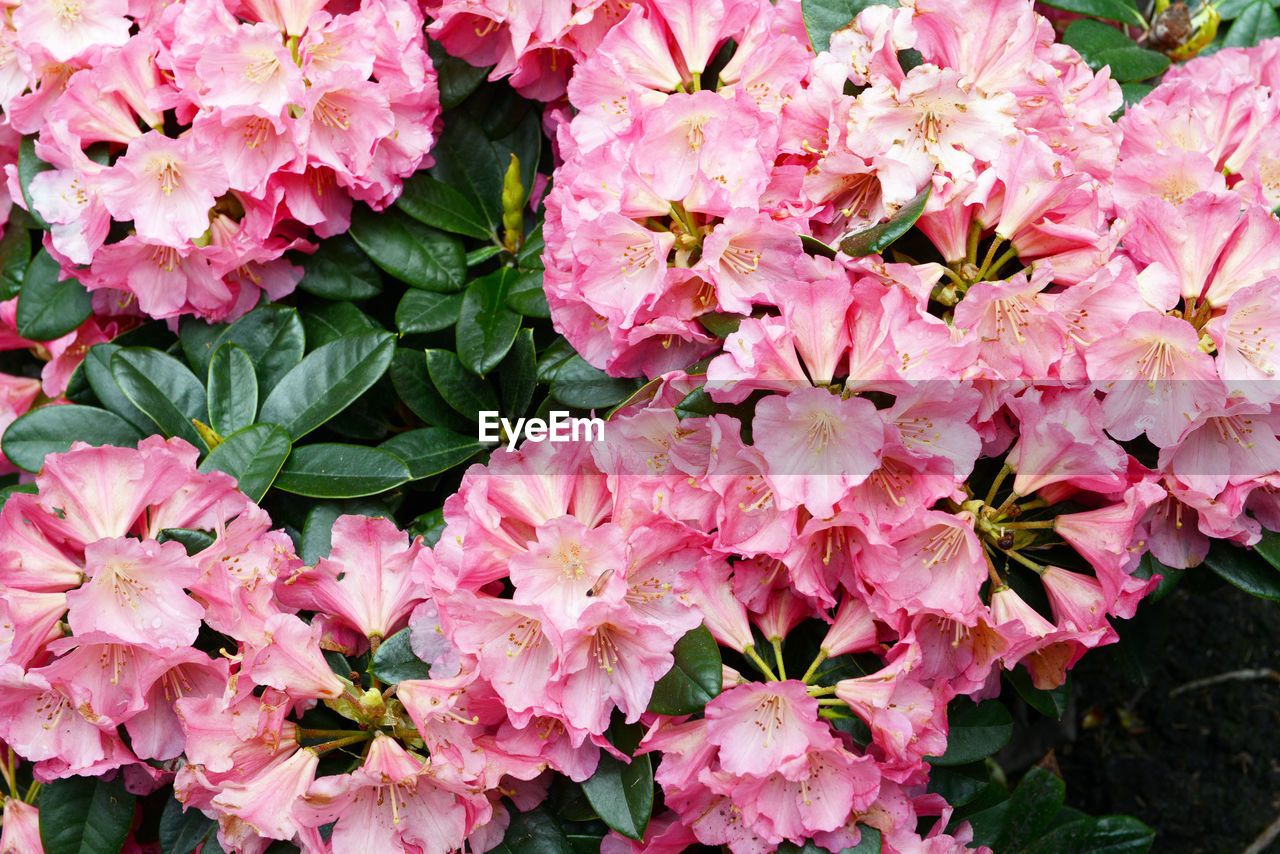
left=100, top=132, right=228, bottom=247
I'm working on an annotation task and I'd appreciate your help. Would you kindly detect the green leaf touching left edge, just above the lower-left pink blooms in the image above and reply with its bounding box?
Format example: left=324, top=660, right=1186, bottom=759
left=3, top=403, right=142, bottom=471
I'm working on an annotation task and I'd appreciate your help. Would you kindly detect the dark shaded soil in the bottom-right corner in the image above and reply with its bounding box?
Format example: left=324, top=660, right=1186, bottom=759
left=1000, top=581, right=1280, bottom=854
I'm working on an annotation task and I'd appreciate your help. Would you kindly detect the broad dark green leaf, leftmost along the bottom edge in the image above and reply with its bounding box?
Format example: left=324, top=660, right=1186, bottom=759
left=40, top=777, right=137, bottom=854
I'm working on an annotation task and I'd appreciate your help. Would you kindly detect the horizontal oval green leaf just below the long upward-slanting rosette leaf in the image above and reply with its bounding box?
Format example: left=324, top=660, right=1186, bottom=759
left=275, top=442, right=411, bottom=498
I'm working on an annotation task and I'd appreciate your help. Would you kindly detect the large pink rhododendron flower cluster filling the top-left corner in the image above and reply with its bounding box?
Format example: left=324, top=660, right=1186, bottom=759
left=0, top=0, right=439, bottom=320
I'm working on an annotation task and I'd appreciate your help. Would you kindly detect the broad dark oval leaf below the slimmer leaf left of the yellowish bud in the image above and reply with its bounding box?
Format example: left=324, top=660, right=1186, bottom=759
left=348, top=207, right=467, bottom=293
